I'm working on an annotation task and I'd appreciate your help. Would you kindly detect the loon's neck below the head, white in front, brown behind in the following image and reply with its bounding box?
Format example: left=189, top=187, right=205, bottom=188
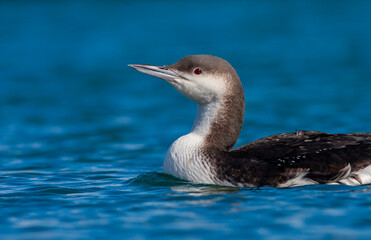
left=192, top=88, right=245, bottom=151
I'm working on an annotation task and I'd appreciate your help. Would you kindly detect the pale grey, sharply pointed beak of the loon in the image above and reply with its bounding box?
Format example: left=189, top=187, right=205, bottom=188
left=128, top=64, right=182, bottom=82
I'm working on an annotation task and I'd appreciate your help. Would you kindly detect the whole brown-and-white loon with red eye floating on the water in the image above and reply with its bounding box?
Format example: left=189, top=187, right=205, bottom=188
left=128, top=55, right=371, bottom=188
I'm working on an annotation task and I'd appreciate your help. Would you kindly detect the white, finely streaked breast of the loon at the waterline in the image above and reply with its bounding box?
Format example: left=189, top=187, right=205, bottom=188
left=163, top=133, right=217, bottom=184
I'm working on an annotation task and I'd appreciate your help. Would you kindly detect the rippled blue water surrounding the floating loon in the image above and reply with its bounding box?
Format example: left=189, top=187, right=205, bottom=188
left=0, top=0, right=371, bottom=239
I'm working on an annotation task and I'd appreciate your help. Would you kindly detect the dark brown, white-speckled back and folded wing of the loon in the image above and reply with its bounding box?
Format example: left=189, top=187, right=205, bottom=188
left=223, top=131, right=371, bottom=186
